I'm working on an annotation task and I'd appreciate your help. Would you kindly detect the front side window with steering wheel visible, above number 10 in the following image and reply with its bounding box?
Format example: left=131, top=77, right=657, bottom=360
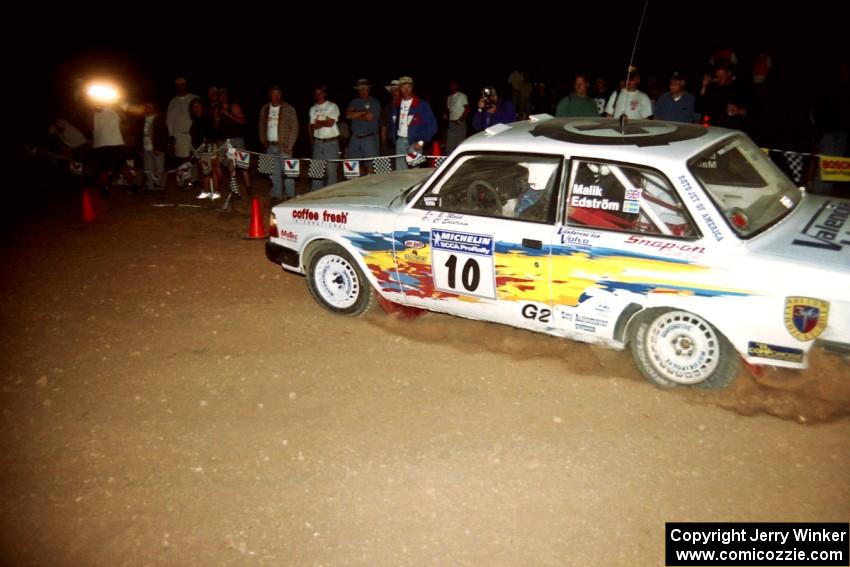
left=416, top=154, right=562, bottom=223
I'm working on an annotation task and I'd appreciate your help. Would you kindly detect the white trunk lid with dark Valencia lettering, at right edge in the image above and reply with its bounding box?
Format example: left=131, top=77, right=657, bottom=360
left=747, top=195, right=850, bottom=274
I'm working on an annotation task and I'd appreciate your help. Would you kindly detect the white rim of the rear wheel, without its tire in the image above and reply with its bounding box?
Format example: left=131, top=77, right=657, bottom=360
left=646, top=311, right=720, bottom=384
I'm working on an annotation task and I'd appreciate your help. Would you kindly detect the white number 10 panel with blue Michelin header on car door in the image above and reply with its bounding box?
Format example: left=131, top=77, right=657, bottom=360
left=431, top=229, right=496, bottom=299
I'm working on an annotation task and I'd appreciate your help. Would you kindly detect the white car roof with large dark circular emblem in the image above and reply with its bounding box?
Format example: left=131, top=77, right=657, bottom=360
left=459, top=115, right=736, bottom=164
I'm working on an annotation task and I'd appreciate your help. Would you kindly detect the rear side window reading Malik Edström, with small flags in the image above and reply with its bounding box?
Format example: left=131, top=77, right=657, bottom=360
left=567, top=159, right=698, bottom=237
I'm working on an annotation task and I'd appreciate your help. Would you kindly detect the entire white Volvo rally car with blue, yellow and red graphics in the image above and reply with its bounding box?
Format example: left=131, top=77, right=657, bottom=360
left=266, top=115, right=850, bottom=388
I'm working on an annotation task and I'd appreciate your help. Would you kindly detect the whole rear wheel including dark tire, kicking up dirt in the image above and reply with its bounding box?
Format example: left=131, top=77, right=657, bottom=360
left=630, top=309, right=739, bottom=390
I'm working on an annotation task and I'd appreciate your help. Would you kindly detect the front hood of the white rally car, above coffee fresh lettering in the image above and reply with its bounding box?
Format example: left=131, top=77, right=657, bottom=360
left=286, top=169, right=434, bottom=212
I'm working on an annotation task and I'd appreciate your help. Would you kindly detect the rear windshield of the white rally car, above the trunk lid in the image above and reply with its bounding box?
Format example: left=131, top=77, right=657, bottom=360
left=688, top=136, right=800, bottom=238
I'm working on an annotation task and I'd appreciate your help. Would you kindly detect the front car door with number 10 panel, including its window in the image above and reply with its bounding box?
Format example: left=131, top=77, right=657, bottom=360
left=393, top=152, right=563, bottom=330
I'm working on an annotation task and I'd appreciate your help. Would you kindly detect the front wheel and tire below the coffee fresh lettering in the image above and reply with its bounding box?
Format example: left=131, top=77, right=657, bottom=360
left=307, top=242, right=375, bottom=317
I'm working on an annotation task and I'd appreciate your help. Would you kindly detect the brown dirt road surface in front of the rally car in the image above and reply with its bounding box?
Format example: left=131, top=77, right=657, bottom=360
left=0, top=179, right=850, bottom=566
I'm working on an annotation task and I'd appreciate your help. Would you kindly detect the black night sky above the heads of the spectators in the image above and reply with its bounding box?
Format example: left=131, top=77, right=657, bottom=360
left=14, top=0, right=848, bottom=150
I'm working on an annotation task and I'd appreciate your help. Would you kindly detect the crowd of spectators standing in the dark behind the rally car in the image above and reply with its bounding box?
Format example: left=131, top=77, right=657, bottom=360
left=41, top=50, right=850, bottom=201
